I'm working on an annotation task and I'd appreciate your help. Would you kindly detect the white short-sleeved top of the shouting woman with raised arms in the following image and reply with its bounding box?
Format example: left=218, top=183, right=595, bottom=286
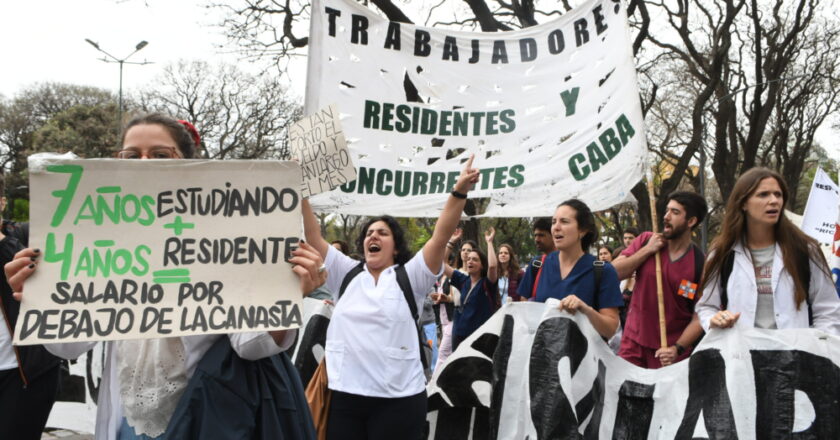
left=325, top=246, right=443, bottom=398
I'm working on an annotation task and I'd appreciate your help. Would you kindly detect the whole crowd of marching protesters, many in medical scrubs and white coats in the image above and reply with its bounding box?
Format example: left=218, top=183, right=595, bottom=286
left=0, top=114, right=840, bottom=440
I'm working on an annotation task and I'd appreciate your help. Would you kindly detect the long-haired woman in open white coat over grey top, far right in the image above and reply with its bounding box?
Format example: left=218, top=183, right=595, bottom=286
left=697, top=168, right=840, bottom=335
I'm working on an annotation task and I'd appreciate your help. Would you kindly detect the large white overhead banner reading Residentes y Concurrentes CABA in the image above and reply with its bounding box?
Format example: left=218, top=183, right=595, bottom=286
left=306, top=0, right=646, bottom=217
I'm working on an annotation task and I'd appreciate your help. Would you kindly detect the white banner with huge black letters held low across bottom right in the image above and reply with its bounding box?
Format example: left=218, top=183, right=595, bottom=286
left=427, top=300, right=840, bottom=440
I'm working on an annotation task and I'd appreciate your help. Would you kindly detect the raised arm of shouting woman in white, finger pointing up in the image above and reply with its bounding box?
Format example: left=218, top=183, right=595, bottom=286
left=420, top=155, right=479, bottom=273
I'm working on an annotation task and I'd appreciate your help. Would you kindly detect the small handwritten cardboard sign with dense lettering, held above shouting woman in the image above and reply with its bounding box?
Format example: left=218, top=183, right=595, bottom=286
left=289, top=105, right=356, bottom=197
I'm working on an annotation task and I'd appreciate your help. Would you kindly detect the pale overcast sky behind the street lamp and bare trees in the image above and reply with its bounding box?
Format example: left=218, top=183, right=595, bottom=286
left=0, top=0, right=840, bottom=162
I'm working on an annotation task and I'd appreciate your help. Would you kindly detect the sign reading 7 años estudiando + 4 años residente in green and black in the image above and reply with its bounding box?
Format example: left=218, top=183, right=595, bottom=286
left=15, top=158, right=301, bottom=345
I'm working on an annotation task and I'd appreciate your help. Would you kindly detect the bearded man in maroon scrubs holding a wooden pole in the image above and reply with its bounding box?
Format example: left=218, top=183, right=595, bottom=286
left=612, top=191, right=707, bottom=368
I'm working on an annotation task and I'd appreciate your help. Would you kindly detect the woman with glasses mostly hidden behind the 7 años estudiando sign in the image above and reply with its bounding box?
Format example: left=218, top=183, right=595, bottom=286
left=5, top=114, right=326, bottom=440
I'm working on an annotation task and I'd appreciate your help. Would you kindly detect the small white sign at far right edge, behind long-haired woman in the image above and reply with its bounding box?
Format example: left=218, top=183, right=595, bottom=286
left=802, top=168, right=840, bottom=245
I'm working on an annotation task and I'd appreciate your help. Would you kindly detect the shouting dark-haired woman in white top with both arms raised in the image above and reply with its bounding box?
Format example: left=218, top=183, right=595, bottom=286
left=302, top=156, right=479, bottom=440
